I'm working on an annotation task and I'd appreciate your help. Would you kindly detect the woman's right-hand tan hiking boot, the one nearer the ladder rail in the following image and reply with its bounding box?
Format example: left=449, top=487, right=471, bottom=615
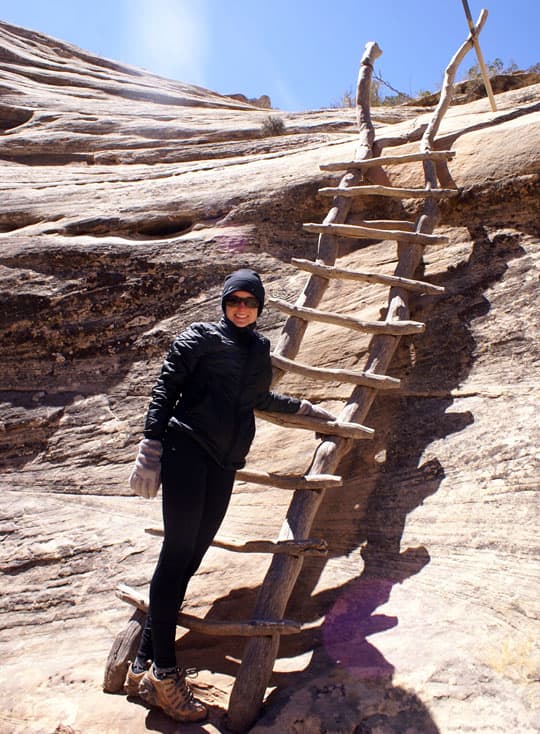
left=139, top=666, right=208, bottom=721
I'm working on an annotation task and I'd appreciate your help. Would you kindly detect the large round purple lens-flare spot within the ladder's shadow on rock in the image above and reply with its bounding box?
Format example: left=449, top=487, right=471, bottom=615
left=322, top=578, right=398, bottom=678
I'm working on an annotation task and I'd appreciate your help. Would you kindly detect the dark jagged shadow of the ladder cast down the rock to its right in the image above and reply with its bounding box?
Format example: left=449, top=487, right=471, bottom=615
left=232, top=228, right=523, bottom=734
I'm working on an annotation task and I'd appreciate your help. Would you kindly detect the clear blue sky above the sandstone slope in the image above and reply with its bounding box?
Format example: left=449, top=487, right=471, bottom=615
left=0, top=0, right=540, bottom=111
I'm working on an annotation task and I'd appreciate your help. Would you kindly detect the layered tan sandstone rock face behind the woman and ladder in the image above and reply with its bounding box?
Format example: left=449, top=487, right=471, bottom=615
left=0, top=24, right=540, bottom=734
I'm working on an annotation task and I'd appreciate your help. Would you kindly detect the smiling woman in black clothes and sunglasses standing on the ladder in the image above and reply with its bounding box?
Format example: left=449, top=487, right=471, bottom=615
left=125, top=269, right=333, bottom=721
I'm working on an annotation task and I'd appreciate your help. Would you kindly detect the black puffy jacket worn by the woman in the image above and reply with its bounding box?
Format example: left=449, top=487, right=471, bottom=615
left=144, top=318, right=300, bottom=469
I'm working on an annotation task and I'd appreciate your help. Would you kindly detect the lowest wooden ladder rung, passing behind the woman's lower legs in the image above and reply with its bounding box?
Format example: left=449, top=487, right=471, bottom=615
left=116, top=584, right=302, bottom=637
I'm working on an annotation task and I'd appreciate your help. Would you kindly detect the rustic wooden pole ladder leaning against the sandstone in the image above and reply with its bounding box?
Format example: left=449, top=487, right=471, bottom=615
left=108, top=10, right=487, bottom=732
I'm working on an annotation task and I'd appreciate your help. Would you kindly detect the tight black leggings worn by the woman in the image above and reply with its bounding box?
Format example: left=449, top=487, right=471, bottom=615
left=137, top=430, right=235, bottom=668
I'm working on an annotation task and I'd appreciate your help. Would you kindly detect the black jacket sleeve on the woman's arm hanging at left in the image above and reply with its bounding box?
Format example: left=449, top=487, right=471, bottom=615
left=143, top=324, right=209, bottom=440
